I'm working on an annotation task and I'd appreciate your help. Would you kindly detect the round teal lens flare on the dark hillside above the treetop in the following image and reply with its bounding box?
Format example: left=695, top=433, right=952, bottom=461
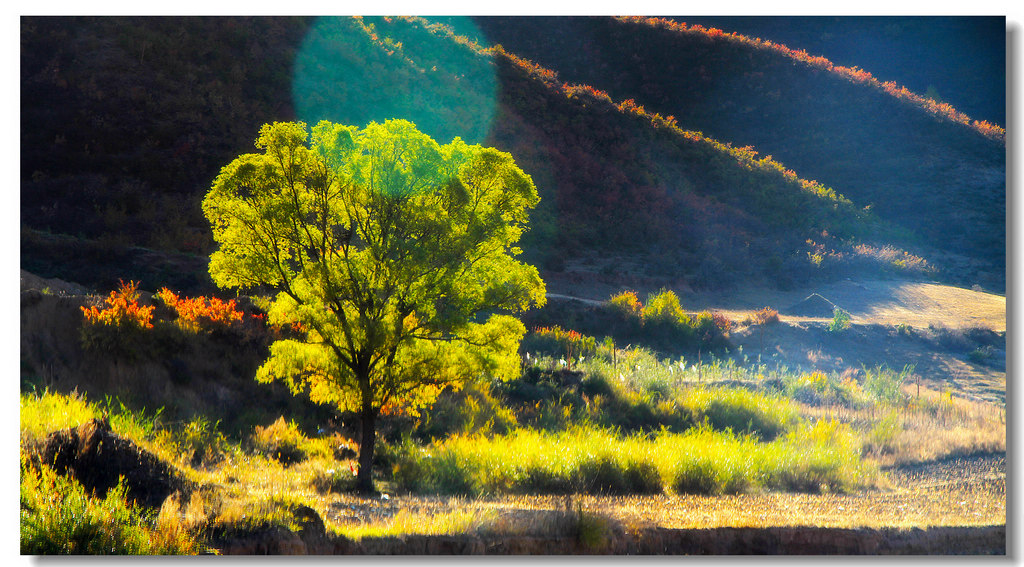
left=292, top=16, right=498, bottom=143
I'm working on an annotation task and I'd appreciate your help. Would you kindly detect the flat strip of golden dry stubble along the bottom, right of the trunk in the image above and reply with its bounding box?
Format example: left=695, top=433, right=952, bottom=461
left=311, top=470, right=1006, bottom=537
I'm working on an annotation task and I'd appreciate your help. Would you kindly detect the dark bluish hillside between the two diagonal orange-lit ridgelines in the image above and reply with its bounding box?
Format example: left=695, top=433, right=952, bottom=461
left=474, top=17, right=1006, bottom=285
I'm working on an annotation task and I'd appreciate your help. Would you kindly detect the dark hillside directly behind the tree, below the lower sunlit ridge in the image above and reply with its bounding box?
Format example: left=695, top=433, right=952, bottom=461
left=22, top=17, right=991, bottom=293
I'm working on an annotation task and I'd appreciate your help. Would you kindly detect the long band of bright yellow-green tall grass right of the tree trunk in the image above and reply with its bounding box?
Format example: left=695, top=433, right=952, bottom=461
left=394, top=422, right=870, bottom=495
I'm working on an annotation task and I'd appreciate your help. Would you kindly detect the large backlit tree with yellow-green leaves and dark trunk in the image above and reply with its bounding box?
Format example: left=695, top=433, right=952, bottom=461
left=203, top=120, right=545, bottom=491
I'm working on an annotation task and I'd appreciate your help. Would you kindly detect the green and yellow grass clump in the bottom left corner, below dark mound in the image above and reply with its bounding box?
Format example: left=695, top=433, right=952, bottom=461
left=20, top=457, right=202, bottom=555
